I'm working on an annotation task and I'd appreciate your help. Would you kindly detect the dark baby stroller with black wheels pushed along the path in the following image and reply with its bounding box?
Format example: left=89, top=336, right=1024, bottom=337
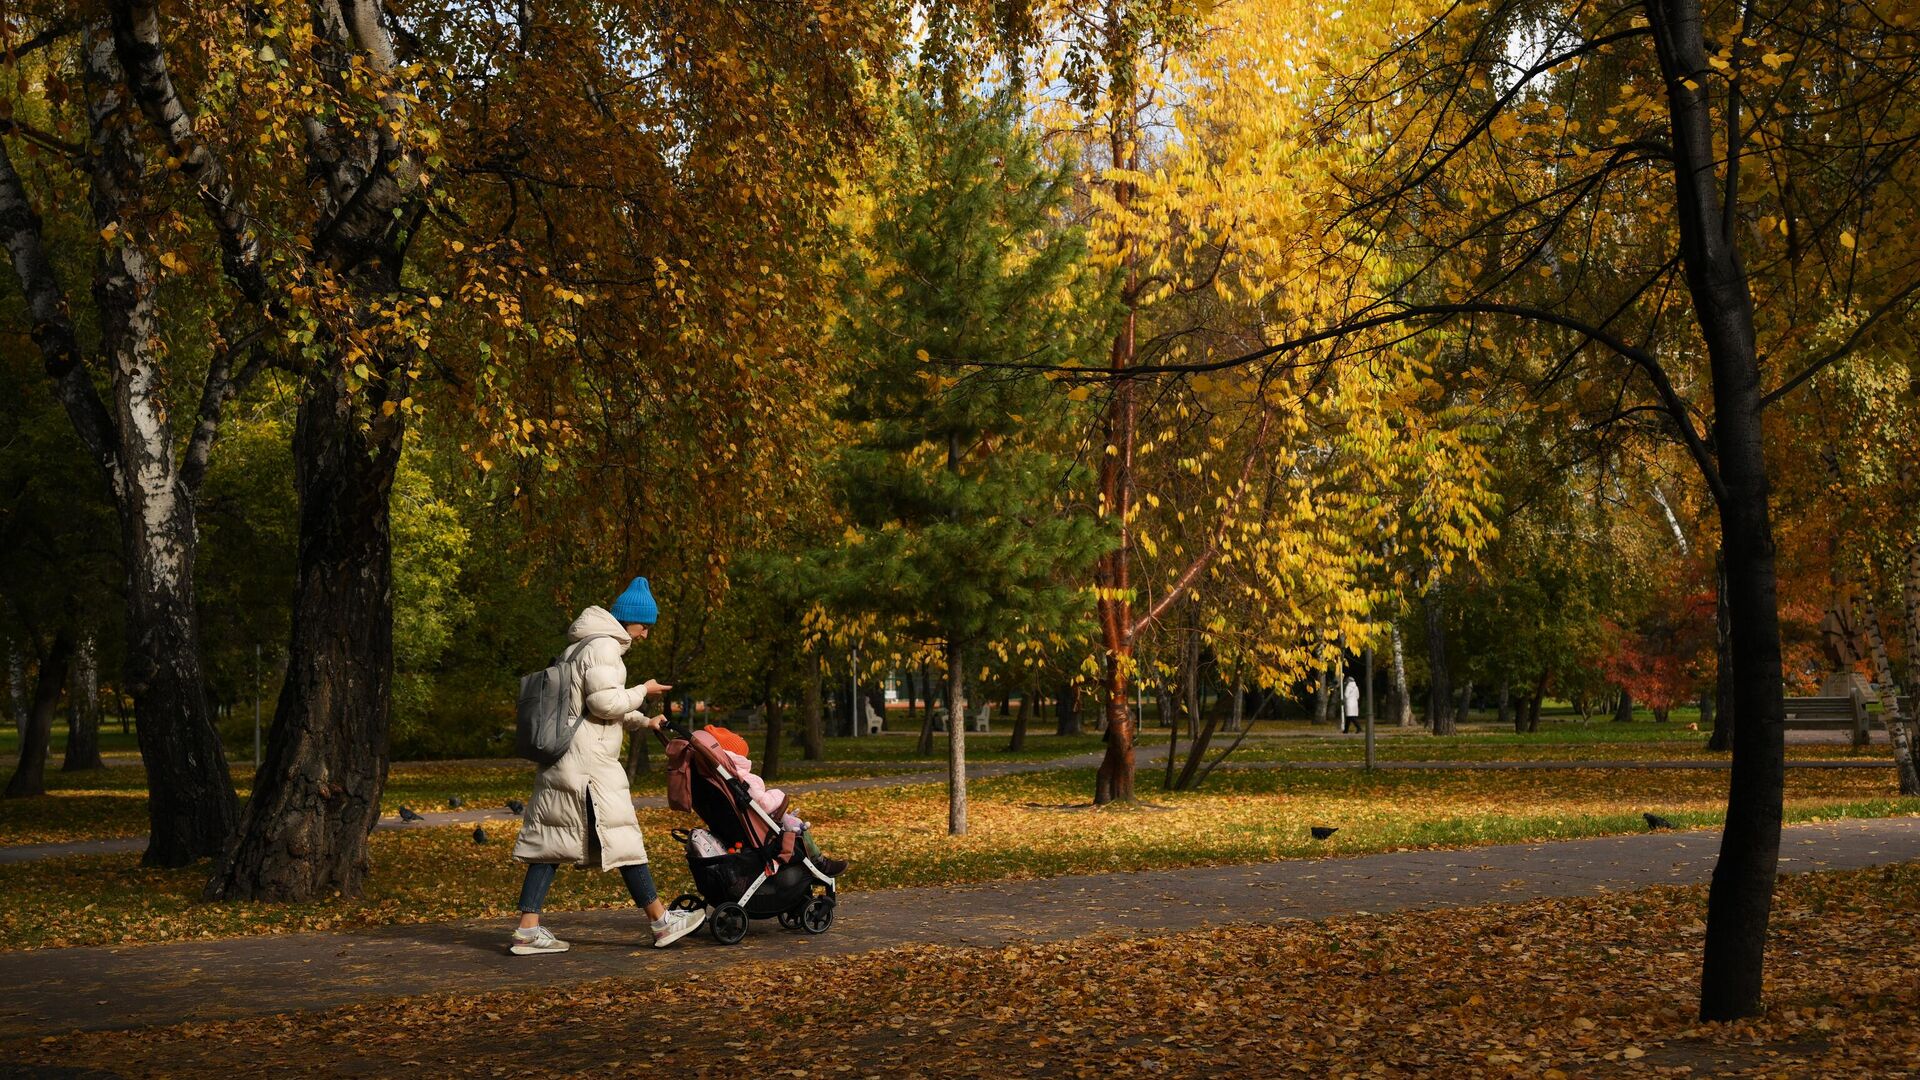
left=660, top=724, right=837, bottom=945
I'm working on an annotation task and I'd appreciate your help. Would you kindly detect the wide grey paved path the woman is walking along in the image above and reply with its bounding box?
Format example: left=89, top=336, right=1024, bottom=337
left=0, top=819, right=1920, bottom=1038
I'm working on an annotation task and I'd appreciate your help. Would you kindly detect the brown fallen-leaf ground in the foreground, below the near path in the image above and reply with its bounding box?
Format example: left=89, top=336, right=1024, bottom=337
left=0, top=853, right=1920, bottom=1080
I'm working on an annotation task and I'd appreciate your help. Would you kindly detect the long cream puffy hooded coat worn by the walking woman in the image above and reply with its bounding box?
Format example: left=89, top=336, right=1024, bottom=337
left=513, top=607, right=647, bottom=871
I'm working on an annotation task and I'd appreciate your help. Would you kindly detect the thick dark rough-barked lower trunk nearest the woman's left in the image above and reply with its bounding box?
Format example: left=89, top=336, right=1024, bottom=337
left=207, top=371, right=405, bottom=901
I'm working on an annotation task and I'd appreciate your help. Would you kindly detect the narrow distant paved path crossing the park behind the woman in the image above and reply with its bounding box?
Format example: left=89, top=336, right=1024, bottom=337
left=0, top=745, right=1893, bottom=867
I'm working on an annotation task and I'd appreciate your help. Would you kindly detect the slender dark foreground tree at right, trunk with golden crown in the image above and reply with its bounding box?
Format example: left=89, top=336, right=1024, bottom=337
left=1152, top=0, right=1920, bottom=1019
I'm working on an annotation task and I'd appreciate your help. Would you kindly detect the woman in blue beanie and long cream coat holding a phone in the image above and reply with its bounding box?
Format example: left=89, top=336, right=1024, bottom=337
left=511, top=578, right=707, bottom=957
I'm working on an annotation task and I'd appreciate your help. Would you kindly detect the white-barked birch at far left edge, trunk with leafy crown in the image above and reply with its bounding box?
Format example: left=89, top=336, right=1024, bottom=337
left=0, top=6, right=251, bottom=853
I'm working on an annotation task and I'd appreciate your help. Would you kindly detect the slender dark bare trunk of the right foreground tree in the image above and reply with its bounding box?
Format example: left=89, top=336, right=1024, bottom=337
left=1645, top=0, right=1786, bottom=1020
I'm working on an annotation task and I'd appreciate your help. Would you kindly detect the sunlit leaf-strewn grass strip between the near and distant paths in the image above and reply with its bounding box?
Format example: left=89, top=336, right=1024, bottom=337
left=0, top=771, right=1920, bottom=949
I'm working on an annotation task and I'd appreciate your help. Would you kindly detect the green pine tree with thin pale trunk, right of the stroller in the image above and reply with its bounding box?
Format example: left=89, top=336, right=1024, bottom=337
left=833, top=98, right=1104, bottom=834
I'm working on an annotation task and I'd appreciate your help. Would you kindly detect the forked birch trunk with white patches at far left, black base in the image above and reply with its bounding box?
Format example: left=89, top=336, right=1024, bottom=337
left=0, top=37, right=236, bottom=867
